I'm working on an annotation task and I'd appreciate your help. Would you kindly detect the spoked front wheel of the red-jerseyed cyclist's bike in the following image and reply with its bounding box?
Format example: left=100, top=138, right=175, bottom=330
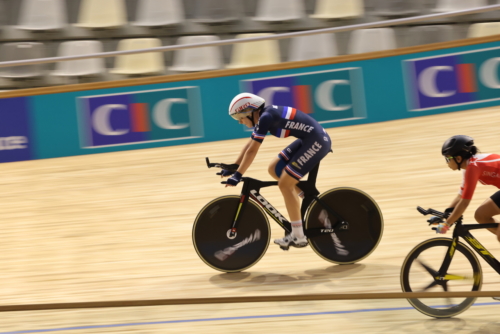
left=401, top=238, right=482, bottom=318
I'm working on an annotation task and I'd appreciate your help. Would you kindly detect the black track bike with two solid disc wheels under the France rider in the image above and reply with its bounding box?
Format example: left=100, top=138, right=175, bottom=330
left=193, top=158, right=383, bottom=272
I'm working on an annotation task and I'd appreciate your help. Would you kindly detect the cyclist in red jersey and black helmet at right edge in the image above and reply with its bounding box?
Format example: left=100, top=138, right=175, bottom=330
left=437, top=135, right=500, bottom=241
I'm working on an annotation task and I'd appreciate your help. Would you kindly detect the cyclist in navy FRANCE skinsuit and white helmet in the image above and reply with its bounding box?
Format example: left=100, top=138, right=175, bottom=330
left=221, top=93, right=331, bottom=248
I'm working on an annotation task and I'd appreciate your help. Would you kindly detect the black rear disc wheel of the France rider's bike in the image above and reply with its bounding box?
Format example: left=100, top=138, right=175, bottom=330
left=305, top=188, right=384, bottom=264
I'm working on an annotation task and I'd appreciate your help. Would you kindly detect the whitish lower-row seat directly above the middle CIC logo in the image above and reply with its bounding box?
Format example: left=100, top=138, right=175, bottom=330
left=288, top=34, right=338, bottom=61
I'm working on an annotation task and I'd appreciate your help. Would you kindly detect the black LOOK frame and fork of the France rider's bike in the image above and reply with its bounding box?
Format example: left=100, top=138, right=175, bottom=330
left=227, top=164, right=349, bottom=238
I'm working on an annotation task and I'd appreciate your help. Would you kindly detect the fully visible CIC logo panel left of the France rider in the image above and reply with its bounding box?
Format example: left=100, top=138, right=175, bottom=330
left=78, top=87, right=203, bottom=148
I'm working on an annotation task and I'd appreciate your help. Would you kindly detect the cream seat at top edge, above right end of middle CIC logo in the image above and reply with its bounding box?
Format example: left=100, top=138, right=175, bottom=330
left=310, top=0, right=364, bottom=20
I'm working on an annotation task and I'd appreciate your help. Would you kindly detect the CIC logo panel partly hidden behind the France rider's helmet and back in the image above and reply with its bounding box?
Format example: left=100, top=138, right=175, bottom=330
left=241, top=67, right=366, bottom=123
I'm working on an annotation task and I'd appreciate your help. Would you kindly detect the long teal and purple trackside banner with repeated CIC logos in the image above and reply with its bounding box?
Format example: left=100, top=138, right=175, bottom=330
left=0, top=37, right=500, bottom=162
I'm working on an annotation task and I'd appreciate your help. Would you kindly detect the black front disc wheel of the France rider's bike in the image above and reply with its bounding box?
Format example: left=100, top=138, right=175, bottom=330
left=193, top=195, right=270, bottom=272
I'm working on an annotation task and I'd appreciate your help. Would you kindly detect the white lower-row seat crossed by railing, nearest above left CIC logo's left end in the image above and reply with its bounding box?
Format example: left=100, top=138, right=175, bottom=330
left=51, top=41, right=106, bottom=77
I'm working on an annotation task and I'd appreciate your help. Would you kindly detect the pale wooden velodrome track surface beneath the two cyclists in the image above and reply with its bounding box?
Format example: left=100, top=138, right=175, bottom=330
left=0, top=108, right=500, bottom=334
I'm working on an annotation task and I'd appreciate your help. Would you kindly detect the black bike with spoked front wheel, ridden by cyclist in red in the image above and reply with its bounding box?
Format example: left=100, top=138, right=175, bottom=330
left=401, top=207, right=500, bottom=318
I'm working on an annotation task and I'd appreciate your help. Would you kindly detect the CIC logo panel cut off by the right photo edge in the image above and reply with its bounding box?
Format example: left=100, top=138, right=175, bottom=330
left=403, top=48, right=500, bottom=111
